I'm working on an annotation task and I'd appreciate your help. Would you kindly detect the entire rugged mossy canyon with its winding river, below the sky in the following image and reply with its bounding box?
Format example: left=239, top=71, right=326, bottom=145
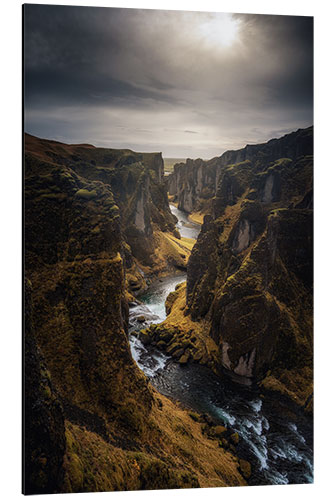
left=24, top=127, right=313, bottom=494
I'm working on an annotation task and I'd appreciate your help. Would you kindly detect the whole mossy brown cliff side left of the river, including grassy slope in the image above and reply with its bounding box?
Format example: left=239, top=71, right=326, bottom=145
left=24, top=136, right=241, bottom=493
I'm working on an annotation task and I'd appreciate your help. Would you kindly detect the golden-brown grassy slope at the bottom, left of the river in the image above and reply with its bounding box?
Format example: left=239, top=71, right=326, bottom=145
left=63, top=389, right=246, bottom=492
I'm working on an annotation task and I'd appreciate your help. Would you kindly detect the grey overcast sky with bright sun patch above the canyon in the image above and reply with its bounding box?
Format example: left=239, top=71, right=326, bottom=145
left=24, top=5, right=313, bottom=158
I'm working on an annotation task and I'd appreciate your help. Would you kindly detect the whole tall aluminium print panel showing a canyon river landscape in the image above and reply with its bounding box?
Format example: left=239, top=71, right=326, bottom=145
left=23, top=4, right=313, bottom=495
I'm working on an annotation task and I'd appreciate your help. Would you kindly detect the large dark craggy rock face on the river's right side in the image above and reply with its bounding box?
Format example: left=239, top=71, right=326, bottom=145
left=183, top=128, right=313, bottom=404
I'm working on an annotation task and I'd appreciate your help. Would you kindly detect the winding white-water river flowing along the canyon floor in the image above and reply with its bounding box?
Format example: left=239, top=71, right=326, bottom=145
left=130, top=206, right=313, bottom=485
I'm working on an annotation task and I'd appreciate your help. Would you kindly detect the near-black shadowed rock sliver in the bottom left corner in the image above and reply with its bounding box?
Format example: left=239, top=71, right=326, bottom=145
left=23, top=280, right=66, bottom=495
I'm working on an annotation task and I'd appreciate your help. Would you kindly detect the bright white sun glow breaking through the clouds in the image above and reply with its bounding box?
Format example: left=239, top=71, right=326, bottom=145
left=199, top=14, right=240, bottom=47
